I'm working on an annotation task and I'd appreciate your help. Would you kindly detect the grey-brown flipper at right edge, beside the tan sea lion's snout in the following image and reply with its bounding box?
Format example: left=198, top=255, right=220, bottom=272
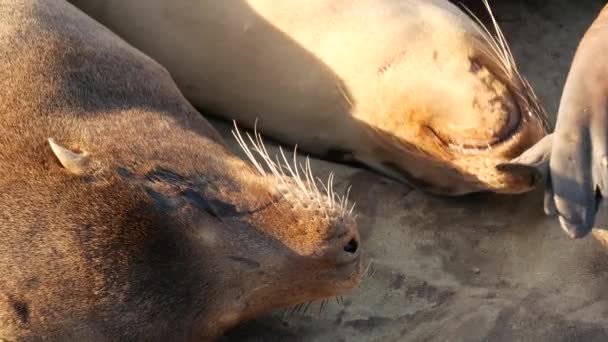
left=502, top=6, right=608, bottom=238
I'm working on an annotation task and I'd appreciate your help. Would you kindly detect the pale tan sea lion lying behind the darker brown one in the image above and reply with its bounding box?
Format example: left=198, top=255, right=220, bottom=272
left=71, top=0, right=546, bottom=195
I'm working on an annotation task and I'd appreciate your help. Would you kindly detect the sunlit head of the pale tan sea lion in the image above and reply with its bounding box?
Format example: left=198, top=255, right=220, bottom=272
left=353, top=2, right=547, bottom=195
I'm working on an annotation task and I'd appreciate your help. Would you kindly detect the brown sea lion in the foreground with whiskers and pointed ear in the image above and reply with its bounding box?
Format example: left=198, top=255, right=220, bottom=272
left=0, top=0, right=362, bottom=341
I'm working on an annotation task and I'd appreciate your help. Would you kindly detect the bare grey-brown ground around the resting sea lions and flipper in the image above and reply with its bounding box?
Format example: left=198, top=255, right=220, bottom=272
left=208, top=0, right=608, bottom=341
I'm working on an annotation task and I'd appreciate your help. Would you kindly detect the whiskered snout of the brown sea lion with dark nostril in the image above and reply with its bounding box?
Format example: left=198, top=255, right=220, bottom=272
left=188, top=124, right=364, bottom=336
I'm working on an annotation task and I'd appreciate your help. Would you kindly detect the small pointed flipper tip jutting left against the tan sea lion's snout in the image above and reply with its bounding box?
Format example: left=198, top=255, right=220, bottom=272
left=496, top=134, right=553, bottom=181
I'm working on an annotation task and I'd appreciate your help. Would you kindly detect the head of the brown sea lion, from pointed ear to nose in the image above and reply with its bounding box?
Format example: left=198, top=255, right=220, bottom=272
left=41, top=125, right=363, bottom=338
